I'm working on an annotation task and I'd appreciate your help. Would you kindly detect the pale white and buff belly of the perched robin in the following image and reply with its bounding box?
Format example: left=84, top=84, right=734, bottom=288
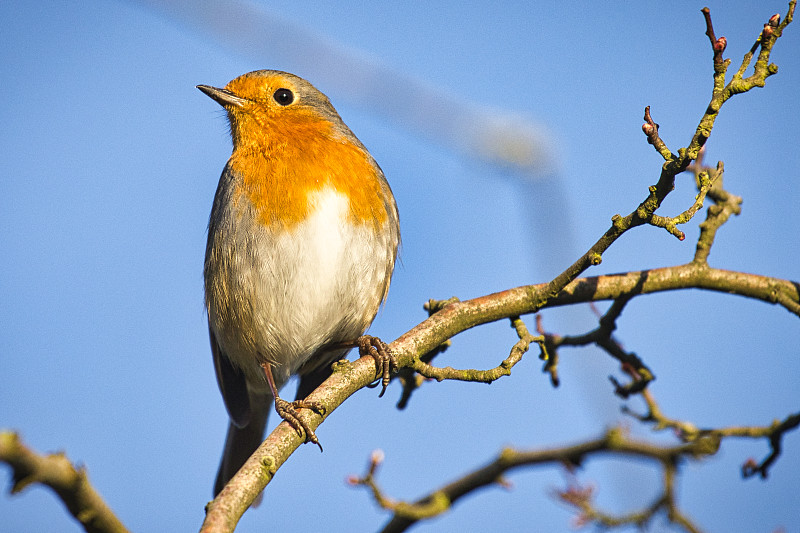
left=209, top=189, right=396, bottom=387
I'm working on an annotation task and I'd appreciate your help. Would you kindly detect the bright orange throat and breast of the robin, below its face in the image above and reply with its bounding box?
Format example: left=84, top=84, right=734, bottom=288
left=229, top=113, right=388, bottom=229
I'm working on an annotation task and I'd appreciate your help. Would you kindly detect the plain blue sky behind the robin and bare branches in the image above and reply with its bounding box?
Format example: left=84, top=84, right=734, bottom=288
left=0, top=0, right=800, bottom=532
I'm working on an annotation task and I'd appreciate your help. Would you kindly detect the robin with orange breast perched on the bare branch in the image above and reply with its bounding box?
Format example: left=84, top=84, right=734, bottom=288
left=197, top=70, right=400, bottom=494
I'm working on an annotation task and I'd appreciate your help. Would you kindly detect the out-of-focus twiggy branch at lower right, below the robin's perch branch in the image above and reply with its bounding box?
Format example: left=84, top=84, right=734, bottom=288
left=360, top=402, right=800, bottom=533
